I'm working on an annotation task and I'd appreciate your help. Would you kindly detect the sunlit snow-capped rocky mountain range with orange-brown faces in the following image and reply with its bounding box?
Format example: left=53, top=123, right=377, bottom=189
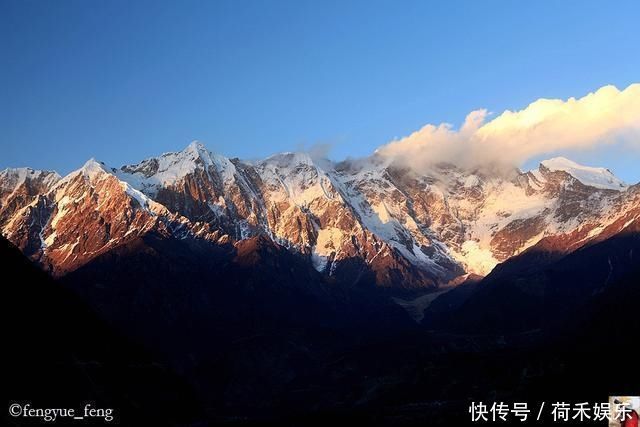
left=0, top=142, right=640, bottom=289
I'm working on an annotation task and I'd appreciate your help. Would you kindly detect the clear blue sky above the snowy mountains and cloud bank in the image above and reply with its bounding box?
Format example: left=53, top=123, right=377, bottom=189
left=0, top=0, right=640, bottom=181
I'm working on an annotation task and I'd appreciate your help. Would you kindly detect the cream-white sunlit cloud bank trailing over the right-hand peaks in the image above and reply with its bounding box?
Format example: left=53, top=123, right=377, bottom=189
left=376, top=83, right=640, bottom=170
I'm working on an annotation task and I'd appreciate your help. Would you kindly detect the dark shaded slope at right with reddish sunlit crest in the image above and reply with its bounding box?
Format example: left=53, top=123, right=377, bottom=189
left=425, top=216, right=640, bottom=336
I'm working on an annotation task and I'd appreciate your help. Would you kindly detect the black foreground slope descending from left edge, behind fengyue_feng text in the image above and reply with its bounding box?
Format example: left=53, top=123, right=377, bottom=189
left=0, top=239, right=203, bottom=425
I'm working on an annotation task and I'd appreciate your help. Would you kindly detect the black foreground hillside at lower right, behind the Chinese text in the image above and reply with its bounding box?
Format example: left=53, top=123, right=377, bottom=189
left=208, top=286, right=640, bottom=426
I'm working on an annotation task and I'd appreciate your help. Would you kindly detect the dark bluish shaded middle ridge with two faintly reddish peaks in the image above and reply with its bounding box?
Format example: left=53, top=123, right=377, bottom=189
left=63, top=233, right=416, bottom=415
